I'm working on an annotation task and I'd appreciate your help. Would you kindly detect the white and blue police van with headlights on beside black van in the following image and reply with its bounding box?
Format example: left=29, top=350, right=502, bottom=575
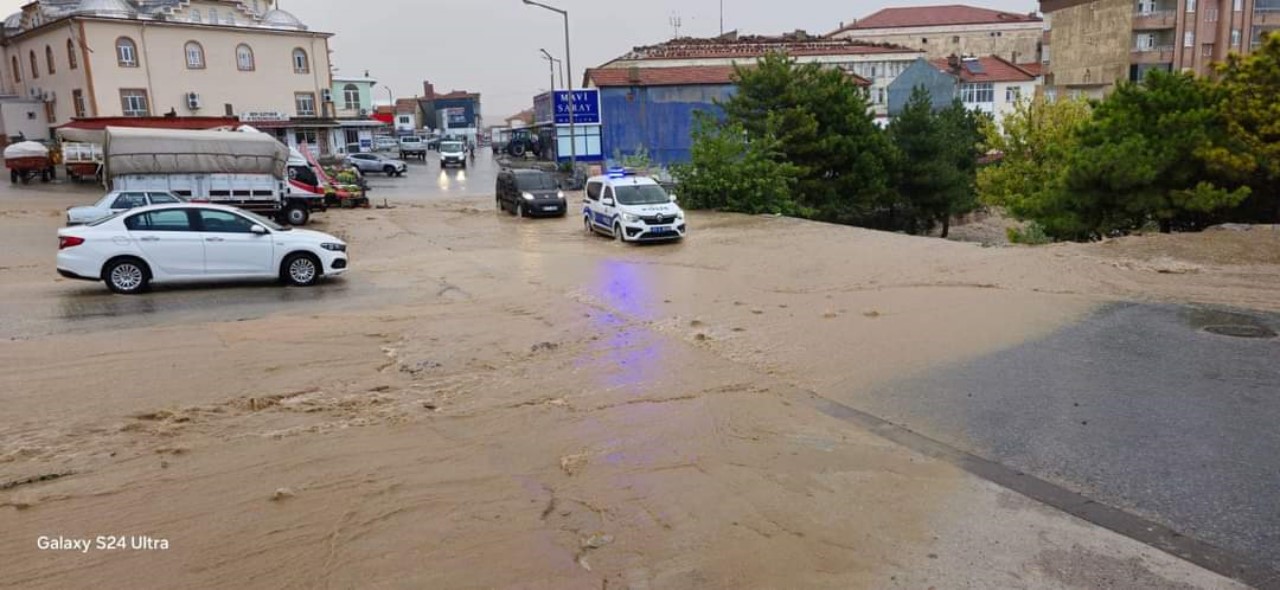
left=582, top=169, right=685, bottom=242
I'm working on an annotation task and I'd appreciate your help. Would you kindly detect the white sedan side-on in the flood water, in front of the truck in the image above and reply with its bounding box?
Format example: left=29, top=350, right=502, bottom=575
left=58, top=203, right=347, bottom=294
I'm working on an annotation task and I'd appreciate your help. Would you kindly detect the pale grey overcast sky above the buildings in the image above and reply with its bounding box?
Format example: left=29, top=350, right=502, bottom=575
left=0, top=0, right=1037, bottom=119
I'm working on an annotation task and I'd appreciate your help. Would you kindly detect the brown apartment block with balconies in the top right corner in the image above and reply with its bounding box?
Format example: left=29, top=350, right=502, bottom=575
left=1041, top=0, right=1280, bottom=97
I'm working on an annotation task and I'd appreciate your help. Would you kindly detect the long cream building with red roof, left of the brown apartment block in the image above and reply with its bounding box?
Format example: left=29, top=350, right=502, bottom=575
left=831, top=5, right=1042, bottom=64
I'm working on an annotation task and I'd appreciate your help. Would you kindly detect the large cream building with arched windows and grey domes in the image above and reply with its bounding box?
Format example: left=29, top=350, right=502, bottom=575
left=0, top=0, right=337, bottom=154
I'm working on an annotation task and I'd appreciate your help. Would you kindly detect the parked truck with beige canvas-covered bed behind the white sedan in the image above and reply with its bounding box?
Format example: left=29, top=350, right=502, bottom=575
left=102, top=127, right=324, bottom=225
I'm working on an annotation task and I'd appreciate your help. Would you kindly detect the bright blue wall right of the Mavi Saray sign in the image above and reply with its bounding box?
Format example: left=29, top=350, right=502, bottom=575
left=600, top=84, right=737, bottom=166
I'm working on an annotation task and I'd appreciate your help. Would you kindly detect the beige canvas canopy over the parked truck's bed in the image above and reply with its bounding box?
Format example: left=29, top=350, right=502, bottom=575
left=104, top=127, right=289, bottom=179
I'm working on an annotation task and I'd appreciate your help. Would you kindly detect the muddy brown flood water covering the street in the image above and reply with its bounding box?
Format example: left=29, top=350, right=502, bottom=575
left=0, top=156, right=1280, bottom=589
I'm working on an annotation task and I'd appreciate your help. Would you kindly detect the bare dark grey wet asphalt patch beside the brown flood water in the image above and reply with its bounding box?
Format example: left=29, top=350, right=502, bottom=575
left=849, top=305, right=1280, bottom=575
